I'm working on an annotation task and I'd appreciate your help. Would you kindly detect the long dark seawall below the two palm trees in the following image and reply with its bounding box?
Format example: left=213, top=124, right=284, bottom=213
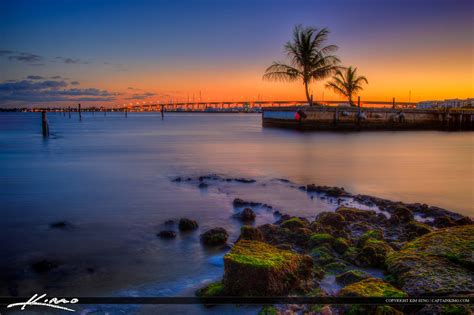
left=262, top=106, right=474, bottom=131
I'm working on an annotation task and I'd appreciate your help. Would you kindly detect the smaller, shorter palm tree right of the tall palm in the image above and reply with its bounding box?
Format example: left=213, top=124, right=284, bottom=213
left=326, top=67, right=369, bottom=106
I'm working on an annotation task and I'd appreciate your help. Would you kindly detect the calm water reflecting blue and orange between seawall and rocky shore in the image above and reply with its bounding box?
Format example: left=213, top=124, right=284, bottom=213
left=0, top=113, right=474, bottom=313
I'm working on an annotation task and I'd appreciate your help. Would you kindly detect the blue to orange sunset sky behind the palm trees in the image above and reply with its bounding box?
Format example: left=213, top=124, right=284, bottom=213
left=0, top=0, right=474, bottom=107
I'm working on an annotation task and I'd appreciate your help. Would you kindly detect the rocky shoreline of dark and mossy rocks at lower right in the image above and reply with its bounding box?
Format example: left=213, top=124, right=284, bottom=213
left=171, top=175, right=474, bottom=314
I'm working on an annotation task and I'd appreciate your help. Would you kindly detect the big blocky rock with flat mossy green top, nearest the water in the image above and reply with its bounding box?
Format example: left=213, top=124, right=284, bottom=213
left=223, top=240, right=312, bottom=296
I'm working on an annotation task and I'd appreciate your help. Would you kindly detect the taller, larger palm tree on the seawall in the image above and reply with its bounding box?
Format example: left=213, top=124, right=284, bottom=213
left=263, top=25, right=340, bottom=105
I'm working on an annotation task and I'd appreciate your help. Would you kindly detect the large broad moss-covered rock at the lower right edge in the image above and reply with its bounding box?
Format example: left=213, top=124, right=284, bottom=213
left=386, top=225, right=474, bottom=296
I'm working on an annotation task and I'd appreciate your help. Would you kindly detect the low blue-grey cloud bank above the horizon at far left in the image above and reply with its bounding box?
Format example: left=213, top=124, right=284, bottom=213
left=0, top=76, right=120, bottom=105
